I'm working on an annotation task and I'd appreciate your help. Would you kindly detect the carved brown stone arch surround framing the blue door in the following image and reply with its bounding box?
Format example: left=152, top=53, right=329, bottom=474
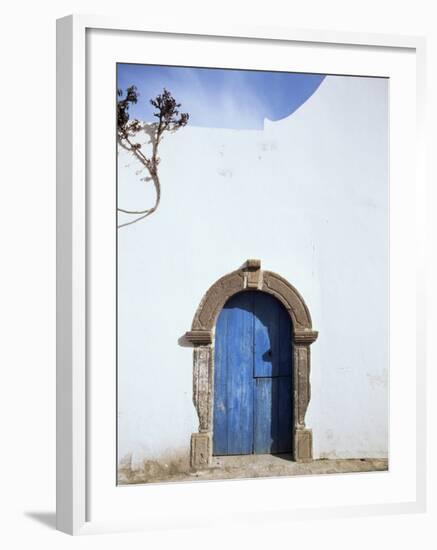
left=185, top=260, right=318, bottom=468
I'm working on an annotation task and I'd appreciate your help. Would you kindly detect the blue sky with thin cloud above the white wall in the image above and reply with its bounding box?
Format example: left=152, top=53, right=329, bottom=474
left=117, top=63, right=325, bottom=129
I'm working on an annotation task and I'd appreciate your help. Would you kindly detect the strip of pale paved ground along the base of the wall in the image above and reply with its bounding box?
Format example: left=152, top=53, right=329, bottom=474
left=119, top=455, right=388, bottom=485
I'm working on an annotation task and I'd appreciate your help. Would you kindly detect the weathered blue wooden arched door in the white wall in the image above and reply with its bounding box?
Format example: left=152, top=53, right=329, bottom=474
left=213, top=291, right=292, bottom=455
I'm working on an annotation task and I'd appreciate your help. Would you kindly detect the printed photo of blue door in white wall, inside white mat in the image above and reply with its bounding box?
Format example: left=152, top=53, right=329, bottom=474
left=116, top=64, right=390, bottom=485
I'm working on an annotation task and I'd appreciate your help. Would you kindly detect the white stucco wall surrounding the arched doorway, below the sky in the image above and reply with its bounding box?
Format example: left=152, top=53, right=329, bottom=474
left=118, top=77, right=388, bottom=467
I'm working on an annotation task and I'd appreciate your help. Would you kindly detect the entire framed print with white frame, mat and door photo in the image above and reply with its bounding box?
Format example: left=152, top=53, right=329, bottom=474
left=57, top=16, right=425, bottom=534
